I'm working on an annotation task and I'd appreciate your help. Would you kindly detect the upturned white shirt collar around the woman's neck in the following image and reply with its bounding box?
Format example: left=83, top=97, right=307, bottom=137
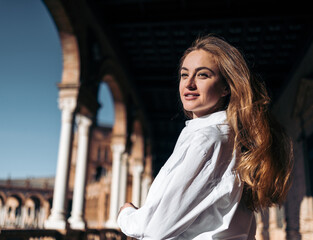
left=185, top=111, right=227, bottom=130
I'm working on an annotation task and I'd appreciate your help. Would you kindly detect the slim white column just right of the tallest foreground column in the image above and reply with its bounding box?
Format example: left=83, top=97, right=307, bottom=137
left=68, top=115, right=92, bottom=230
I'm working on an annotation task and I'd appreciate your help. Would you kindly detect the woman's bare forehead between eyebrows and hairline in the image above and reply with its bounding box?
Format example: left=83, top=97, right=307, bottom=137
left=182, top=49, right=217, bottom=68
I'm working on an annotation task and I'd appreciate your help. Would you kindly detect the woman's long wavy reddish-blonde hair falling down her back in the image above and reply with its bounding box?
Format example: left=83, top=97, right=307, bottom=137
left=181, top=35, right=292, bottom=210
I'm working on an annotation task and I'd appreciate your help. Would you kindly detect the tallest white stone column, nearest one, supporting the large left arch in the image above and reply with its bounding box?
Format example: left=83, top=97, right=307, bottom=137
left=45, top=97, right=77, bottom=230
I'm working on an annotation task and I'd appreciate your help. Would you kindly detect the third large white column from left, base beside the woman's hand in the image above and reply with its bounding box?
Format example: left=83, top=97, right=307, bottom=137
left=106, top=144, right=125, bottom=228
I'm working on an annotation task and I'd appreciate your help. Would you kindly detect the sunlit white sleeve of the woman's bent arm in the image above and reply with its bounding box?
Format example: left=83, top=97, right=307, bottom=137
left=118, top=128, right=242, bottom=239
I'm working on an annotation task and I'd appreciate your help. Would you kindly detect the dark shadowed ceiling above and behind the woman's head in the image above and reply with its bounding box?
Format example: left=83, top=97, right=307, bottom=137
left=83, top=0, right=313, bottom=176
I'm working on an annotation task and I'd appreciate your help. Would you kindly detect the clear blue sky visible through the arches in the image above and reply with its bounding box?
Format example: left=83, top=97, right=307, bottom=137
left=0, top=0, right=113, bottom=179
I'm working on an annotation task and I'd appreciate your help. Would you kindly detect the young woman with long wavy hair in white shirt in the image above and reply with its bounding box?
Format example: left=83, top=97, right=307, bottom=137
left=118, top=35, right=292, bottom=240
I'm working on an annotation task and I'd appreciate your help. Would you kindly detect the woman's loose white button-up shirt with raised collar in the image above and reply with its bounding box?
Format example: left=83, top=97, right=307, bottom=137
left=118, top=111, right=256, bottom=240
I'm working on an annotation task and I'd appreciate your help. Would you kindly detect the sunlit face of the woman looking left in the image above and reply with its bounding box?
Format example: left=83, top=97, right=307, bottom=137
left=179, top=50, right=228, bottom=118
